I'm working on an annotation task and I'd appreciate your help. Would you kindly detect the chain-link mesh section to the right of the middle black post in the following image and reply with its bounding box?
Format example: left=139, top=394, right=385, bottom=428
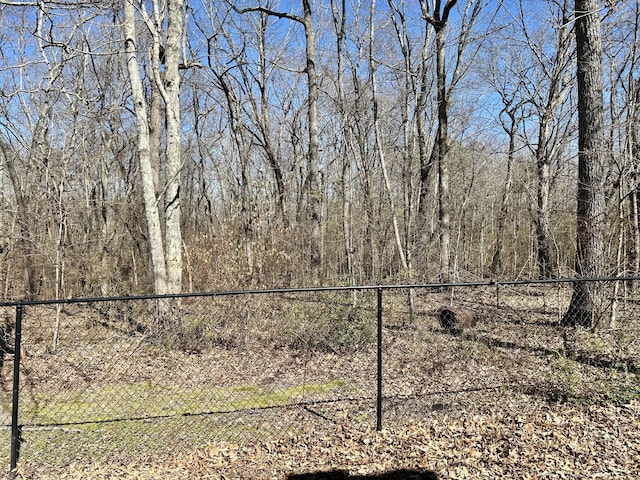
left=384, top=281, right=640, bottom=424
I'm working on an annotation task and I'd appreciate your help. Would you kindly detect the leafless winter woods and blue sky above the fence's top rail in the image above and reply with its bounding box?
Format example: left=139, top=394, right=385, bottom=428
left=0, top=0, right=640, bottom=300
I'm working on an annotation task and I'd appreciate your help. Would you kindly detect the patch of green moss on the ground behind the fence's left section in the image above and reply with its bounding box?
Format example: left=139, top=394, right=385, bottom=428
left=12, top=381, right=345, bottom=465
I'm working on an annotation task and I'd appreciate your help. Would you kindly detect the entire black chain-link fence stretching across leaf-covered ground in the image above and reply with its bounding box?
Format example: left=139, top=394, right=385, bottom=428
left=0, top=279, right=640, bottom=473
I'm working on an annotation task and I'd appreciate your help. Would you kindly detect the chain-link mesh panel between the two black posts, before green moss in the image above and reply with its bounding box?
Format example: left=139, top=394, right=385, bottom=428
left=4, top=293, right=376, bottom=465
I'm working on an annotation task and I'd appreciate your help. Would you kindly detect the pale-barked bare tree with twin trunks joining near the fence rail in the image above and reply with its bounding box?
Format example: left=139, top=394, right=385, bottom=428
left=123, top=0, right=184, bottom=294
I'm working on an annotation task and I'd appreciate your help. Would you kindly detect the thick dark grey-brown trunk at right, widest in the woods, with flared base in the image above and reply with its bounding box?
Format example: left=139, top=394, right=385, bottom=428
left=562, top=0, right=606, bottom=327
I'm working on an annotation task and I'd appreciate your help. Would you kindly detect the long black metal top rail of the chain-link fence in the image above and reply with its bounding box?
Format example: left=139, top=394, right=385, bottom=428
left=0, top=276, right=640, bottom=307
